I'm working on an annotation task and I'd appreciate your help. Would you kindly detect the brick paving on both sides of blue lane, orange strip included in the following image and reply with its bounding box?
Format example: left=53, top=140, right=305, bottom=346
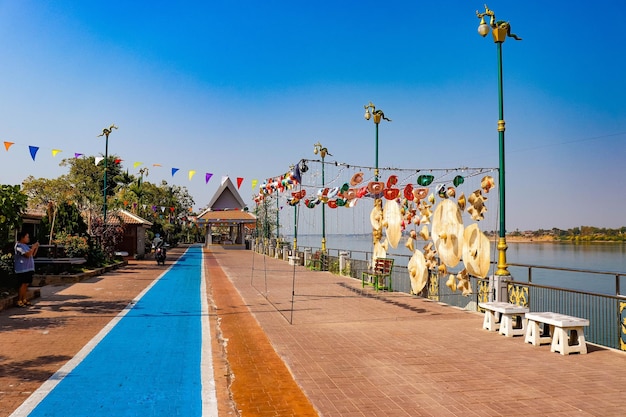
left=0, top=247, right=626, bottom=417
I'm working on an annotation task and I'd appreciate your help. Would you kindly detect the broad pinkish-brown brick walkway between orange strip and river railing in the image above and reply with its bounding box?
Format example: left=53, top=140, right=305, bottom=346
left=207, top=247, right=626, bottom=417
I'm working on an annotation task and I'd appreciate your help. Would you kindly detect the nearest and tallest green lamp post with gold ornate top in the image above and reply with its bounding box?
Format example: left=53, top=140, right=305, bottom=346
left=476, top=4, right=522, bottom=276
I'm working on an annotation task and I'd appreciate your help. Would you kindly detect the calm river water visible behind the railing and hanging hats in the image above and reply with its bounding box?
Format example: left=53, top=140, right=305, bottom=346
left=285, top=234, right=626, bottom=294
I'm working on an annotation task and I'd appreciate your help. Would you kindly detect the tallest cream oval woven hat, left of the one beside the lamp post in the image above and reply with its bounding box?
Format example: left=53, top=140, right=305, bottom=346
left=431, top=200, right=463, bottom=268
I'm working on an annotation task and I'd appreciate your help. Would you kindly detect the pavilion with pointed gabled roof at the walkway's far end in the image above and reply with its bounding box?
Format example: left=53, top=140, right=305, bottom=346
left=197, top=177, right=256, bottom=245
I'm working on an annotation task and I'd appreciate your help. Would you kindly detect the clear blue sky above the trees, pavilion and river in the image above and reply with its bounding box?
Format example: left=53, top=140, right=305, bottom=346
left=0, top=0, right=626, bottom=231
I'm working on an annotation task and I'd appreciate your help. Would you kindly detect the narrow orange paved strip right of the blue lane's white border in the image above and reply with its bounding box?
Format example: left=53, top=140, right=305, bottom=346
left=205, top=247, right=318, bottom=417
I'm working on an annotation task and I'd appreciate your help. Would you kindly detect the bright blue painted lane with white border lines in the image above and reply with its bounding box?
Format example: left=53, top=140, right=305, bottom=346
left=12, top=247, right=217, bottom=417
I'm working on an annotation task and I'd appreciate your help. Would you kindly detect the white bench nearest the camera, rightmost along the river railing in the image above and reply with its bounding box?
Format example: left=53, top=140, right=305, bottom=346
left=524, top=312, right=589, bottom=355
